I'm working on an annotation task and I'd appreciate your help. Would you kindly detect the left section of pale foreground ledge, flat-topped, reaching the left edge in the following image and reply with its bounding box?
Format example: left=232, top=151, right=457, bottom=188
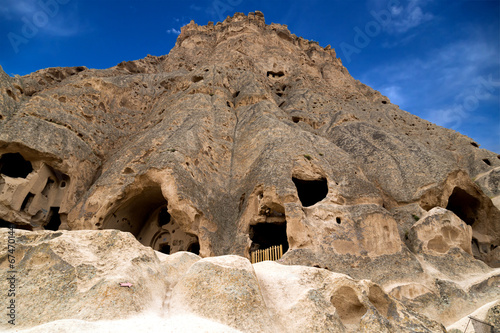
left=0, top=228, right=169, bottom=329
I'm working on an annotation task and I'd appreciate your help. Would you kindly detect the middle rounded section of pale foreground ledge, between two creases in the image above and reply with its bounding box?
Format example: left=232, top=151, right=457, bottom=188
left=169, top=256, right=276, bottom=332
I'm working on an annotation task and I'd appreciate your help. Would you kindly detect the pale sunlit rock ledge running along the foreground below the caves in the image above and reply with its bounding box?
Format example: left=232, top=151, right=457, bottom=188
left=0, top=228, right=445, bottom=333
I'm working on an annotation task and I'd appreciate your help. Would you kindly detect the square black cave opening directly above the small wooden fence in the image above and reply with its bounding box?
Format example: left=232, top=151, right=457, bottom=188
left=249, top=222, right=288, bottom=253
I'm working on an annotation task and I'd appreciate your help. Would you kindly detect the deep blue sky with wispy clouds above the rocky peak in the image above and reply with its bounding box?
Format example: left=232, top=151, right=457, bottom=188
left=0, top=0, right=500, bottom=153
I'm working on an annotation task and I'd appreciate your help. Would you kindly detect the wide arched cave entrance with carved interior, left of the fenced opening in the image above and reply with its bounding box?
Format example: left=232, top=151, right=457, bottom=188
left=103, top=186, right=200, bottom=254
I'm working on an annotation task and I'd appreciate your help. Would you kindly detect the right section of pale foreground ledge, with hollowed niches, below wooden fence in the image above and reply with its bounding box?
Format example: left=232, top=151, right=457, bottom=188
left=254, top=261, right=444, bottom=333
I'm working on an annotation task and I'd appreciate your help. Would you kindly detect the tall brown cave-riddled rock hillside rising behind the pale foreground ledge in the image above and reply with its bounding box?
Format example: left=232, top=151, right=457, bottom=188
left=0, top=13, right=500, bottom=266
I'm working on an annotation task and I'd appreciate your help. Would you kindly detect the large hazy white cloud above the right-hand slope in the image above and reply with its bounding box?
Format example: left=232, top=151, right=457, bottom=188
left=362, top=34, right=500, bottom=130
